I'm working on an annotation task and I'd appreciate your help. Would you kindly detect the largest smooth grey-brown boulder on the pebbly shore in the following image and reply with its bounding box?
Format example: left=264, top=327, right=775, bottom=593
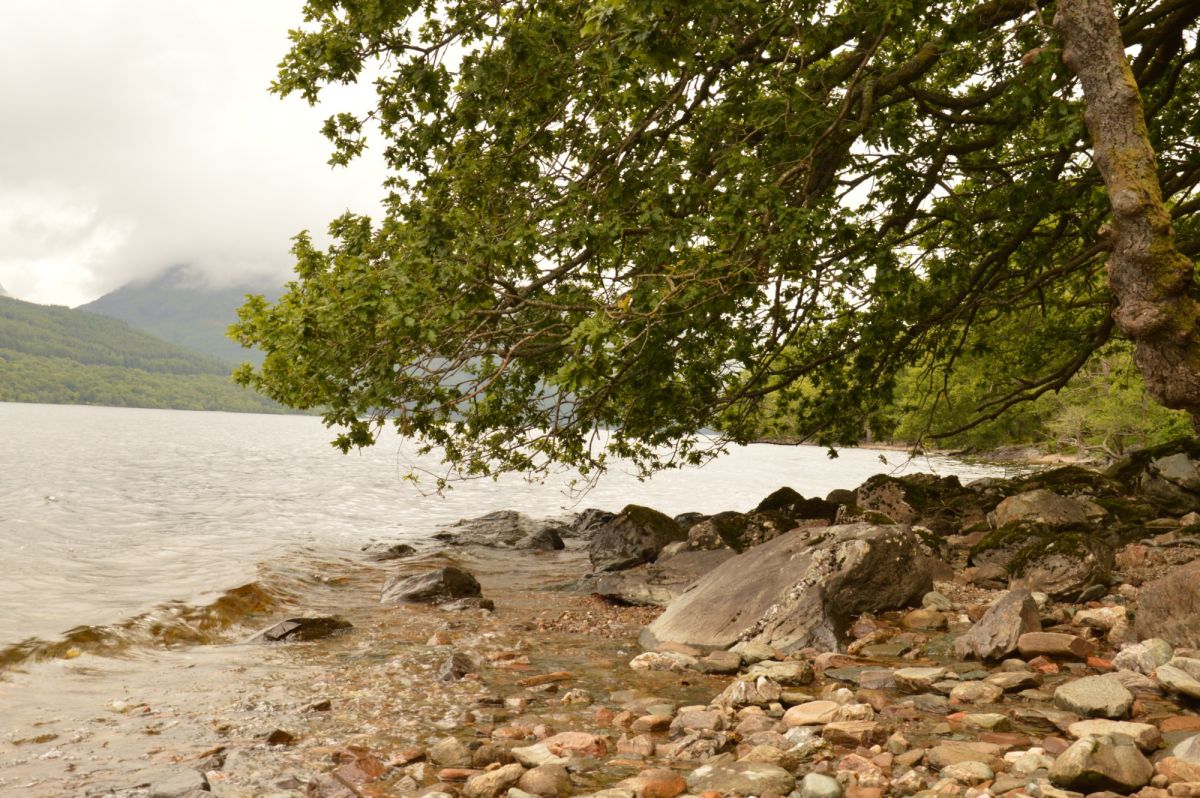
left=642, top=523, right=940, bottom=652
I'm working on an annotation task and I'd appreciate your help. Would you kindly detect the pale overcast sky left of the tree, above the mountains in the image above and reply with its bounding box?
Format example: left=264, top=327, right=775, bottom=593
left=0, top=0, right=383, bottom=306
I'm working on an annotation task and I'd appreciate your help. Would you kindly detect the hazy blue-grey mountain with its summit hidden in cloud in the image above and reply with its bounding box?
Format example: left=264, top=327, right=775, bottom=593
left=78, top=266, right=283, bottom=365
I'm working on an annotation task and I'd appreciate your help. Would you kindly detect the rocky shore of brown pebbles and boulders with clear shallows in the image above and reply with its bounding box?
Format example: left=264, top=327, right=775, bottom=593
left=7, top=443, right=1200, bottom=798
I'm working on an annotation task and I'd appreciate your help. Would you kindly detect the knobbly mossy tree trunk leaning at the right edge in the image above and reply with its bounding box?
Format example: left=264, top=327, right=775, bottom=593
left=1054, top=0, right=1200, bottom=433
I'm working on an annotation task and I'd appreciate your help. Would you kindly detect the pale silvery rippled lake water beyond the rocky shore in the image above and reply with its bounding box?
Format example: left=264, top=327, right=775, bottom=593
left=0, top=403, right=1022, bottom=670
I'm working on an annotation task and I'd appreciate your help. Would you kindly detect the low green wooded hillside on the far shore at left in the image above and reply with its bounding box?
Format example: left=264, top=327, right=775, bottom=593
left=0, top=298, right=284, bottom=413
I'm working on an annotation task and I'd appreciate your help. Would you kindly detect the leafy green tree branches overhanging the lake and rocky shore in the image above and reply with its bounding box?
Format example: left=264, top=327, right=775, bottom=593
left=235, top=0, right=1200, bottom=475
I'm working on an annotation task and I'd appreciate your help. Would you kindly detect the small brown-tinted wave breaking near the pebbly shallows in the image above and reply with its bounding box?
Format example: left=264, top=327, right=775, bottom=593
left=0, top=554, right=355, bottom=673
